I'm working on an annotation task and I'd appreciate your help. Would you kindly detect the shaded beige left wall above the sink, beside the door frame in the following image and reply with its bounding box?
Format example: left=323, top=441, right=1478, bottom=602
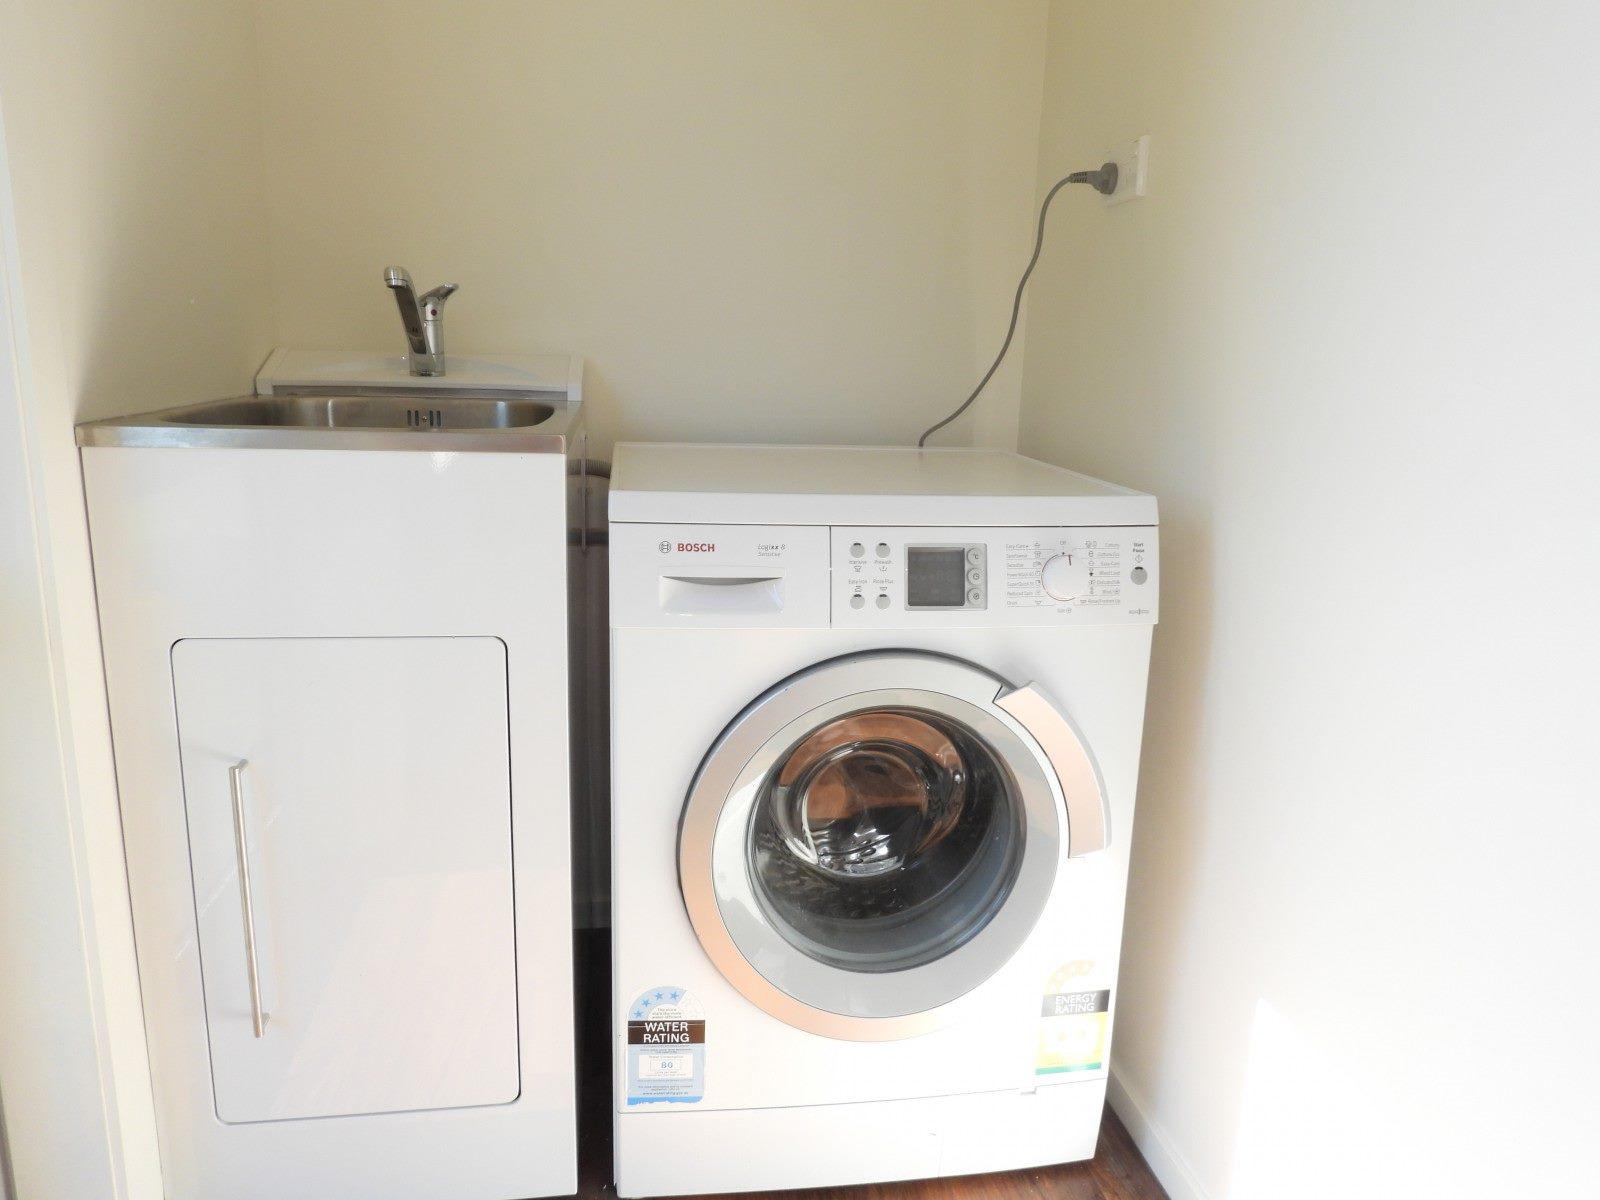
left=0, top=0, right=272, bottom=419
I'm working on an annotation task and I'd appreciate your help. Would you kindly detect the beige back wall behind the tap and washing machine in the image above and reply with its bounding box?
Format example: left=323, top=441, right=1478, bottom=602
left=256, top=0, right=1045, bottom=446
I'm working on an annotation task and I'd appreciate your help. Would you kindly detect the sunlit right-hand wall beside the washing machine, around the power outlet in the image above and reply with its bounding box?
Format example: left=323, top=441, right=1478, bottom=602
left=1021, top=0, right=1600, bottom=1200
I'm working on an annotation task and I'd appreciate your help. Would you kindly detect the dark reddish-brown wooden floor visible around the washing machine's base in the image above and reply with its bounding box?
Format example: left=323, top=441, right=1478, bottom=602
left=578, top=934, right=1166, bottom=1200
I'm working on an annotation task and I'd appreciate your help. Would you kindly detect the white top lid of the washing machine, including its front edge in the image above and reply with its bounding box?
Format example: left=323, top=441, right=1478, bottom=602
left=611, top=442, right=1157, bottom=526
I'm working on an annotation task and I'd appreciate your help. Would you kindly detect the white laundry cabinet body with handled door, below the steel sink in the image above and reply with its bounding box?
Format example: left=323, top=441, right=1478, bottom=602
left=83, top=438, right=578, bottom=1200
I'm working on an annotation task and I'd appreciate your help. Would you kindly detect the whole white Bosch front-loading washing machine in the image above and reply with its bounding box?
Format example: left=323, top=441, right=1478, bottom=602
left=611, top=445, right=1160, bottom=1197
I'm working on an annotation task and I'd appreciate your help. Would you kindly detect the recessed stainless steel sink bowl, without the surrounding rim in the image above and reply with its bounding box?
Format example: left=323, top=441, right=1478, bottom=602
left=158, top=395, right=555, bottom=430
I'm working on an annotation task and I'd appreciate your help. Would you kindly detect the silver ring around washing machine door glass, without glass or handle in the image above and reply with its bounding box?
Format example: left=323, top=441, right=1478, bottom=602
left=678, top=651, right=1064, bottom=1040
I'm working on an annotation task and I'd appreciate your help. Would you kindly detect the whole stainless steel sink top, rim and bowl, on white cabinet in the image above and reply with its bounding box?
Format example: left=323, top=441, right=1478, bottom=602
left=77, top=387, right=576, bottom=453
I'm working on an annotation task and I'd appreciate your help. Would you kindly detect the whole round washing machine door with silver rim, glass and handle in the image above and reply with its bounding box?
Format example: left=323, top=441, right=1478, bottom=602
left=678, top=651, right=1109, bottom=1040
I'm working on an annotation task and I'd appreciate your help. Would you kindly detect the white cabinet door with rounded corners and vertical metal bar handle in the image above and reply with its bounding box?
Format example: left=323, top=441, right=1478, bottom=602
left=171, top=637, right=521, bottom=1123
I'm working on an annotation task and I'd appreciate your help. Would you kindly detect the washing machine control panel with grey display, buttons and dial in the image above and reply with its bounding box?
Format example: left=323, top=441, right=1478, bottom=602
left=830, top=526, right=1157, bottom=627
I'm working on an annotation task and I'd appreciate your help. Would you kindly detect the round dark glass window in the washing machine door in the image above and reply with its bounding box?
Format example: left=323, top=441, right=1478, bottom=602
left=749, top=707, right=1027, bottom=971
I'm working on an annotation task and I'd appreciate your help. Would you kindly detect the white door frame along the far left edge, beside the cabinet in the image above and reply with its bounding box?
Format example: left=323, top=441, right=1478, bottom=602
left=0, top=91, right=162, bottom=1200
